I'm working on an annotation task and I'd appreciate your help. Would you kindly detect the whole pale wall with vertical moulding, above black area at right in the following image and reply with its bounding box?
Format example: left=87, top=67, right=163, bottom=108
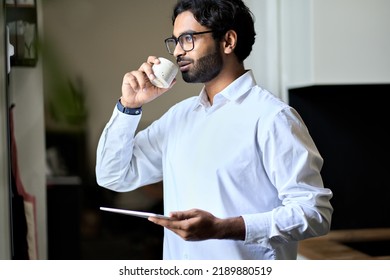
left=279, top=0, right=390, bottom=100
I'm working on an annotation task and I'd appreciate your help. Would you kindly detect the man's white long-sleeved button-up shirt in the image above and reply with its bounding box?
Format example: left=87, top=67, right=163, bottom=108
left=96, top=71, right=333, bottom=260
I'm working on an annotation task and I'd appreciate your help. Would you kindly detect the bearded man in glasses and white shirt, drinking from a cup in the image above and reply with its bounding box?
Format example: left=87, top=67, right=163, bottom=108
left=96, top=0, right=333, bottom=260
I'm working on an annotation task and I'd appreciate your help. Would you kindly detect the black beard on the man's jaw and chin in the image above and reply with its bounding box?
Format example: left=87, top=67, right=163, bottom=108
left=182, top=51, right=223, bottom=83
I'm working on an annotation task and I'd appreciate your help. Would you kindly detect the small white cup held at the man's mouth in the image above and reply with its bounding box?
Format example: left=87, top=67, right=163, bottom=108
left=151, top=57, right=179, bottom=88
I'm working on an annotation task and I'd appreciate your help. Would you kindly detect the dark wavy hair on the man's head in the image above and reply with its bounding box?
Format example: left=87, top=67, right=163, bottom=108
left=172, top=0, right=256, bottom=62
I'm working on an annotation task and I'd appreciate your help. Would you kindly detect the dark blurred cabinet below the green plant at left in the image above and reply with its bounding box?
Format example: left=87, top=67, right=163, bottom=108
left=46, top=130, right=85, bottom=260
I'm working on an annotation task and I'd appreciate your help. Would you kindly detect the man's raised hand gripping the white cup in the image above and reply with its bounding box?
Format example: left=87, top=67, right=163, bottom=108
left=121, top=56, right=176, bottom=108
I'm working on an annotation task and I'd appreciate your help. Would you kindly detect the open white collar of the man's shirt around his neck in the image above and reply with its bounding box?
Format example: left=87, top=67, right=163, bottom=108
left=194, top=70, right=256, bottom=109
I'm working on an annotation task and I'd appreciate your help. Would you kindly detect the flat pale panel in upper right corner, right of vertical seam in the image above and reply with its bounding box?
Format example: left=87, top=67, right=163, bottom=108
left=313, top=0, right=390, bottom=84
